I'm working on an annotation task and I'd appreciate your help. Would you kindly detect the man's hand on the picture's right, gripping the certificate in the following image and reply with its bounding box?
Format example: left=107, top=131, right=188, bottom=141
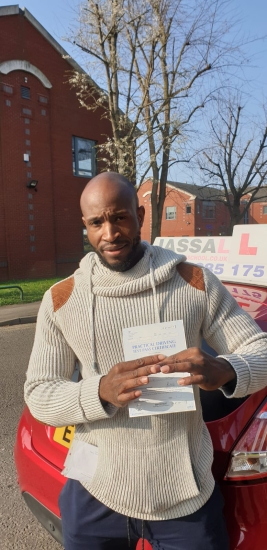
left=156, top=348, right=236, bottom=391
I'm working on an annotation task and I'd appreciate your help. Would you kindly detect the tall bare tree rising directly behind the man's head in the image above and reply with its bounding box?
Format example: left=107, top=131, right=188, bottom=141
left=71, top=0, right=247, bottom=242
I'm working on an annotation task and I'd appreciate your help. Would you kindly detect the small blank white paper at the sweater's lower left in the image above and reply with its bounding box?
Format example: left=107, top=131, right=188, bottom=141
left=62, top=439, right=98, bottom=481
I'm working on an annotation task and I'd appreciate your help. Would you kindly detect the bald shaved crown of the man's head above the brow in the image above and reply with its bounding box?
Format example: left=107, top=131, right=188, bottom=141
left=80, top=172, right=138, bottom=215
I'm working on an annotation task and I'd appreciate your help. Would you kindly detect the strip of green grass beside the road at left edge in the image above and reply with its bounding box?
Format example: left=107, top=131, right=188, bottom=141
left=0, top=278, right=61, bottom=306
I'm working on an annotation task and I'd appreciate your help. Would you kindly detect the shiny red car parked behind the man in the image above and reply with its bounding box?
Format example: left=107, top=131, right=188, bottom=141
left=15, top=283, right=267, bottom=550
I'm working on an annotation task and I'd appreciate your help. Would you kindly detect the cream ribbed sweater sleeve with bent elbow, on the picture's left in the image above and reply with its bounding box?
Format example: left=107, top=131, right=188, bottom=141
left=24, top=290, right=117, bottom=426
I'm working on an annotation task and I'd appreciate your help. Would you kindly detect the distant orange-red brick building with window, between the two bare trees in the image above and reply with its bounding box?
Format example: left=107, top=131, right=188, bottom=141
left=138, top=179, right=229, bottom=241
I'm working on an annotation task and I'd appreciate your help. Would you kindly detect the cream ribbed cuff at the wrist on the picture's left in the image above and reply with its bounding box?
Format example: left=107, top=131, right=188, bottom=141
left=80, top=376, right=118, bottom=422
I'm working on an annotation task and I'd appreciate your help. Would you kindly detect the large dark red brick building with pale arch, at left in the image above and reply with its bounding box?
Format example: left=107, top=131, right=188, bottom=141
left=0, top=6, right=111, bottom=281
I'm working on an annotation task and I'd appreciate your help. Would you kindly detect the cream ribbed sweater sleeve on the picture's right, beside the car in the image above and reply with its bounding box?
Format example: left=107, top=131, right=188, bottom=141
left=203, top=269, right=267, bottom=397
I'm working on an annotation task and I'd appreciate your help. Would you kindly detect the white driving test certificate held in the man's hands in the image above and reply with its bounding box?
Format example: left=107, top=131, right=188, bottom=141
left=123, top=321, right=196, bottom=417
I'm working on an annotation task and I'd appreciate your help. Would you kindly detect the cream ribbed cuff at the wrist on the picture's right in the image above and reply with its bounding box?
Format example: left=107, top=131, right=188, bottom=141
left=218, top=354, right=250, bottom=397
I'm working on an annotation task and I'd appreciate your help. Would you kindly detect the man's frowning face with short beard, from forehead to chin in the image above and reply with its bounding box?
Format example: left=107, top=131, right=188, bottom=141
left=83, top=182, right=144, bottom=271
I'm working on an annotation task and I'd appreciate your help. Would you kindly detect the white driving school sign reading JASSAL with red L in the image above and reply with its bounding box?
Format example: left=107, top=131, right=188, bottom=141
left=154, top=224, right=267, bottom=285
